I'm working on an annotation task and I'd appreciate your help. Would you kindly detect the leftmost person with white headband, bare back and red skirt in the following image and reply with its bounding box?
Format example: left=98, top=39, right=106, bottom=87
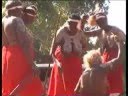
left=2, top=1, right=44, bottom=96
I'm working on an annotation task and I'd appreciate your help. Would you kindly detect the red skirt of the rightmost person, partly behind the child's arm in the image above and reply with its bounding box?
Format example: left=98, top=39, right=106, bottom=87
left=103, top=48, right=123, bottom=93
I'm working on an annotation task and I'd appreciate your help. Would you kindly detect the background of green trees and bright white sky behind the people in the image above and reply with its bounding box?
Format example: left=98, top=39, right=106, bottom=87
left=2, top=0, right=126, bottom=63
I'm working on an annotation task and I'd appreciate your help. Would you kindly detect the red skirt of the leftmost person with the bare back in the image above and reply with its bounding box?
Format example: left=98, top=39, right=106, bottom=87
left=2, top=45, right=44, bottom=96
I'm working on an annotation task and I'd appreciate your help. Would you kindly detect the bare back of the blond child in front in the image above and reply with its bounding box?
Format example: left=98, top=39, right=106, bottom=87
left=82, top=64, right=108, bottom=96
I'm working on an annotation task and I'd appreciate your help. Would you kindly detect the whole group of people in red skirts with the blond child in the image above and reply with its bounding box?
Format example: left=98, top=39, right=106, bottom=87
left=2, top=1, right=126, bottom=96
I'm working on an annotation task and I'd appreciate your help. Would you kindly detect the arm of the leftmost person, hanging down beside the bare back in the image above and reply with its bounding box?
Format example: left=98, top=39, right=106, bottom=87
left=13, top=18, right=34, bottom=66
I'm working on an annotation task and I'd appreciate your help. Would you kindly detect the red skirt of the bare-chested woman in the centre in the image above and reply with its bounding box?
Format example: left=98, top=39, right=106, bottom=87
left=48, top=48, right=82, bottom=96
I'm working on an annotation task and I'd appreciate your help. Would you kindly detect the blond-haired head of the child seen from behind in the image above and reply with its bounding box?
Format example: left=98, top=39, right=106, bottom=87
left=83, top=49, right=102, bottom=68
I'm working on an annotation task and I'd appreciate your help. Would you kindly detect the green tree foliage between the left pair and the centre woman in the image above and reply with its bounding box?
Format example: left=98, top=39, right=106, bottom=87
left=2, top=0, right=108, bottom=61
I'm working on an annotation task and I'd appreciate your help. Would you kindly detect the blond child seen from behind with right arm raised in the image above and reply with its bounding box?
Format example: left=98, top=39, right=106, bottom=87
left=74, top=36, right=122, bottom=96
